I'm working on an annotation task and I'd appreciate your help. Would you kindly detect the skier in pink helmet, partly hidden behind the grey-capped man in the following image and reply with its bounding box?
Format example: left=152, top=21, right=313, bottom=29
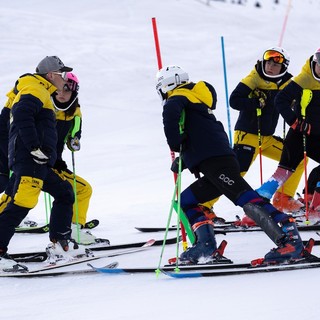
left=52, top=72, right=106, bottom=245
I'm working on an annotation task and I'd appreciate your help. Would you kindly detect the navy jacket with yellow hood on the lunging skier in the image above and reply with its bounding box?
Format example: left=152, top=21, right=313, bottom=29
left=162, top=81, right=235, bottom=172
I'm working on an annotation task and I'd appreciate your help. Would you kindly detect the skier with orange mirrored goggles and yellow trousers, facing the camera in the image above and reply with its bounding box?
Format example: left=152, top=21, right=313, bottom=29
left=201, top=47, right=304, bottom=225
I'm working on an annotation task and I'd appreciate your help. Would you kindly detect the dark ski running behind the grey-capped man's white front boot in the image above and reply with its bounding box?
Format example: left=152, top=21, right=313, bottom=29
left=10, top=237, right=177, bottom=262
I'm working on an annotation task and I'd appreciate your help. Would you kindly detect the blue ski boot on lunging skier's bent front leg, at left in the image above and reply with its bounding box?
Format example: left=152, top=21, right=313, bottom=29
left=179, top=220, right=217, bottom=264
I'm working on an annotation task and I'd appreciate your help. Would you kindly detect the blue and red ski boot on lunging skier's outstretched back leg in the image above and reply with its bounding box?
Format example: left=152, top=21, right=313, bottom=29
left=264, top=217, right=304, bottom=264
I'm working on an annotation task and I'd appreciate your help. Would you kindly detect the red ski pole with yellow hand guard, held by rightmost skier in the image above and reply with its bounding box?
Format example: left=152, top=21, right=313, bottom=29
left=300, top=89, right=313, bottom=224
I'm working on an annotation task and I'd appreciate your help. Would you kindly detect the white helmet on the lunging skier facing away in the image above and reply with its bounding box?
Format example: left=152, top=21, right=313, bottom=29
left=156, top=66, right=189, bottom=99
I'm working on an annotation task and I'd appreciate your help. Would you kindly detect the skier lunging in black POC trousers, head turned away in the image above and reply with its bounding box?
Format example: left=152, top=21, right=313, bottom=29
left=156, top=66, right=304, bottom=263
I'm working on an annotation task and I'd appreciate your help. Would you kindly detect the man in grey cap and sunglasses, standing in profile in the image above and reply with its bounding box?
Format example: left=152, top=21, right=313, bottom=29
left=0, top=56, right=86, bottom=270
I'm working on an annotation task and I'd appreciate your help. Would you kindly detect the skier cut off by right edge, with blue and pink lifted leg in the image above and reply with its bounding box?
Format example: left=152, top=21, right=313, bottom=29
left=257, top=49, right=320, bottom=222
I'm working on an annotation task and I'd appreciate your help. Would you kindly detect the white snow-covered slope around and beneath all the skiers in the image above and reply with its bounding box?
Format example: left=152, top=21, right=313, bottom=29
left=0, top=0, right=320, bottom=320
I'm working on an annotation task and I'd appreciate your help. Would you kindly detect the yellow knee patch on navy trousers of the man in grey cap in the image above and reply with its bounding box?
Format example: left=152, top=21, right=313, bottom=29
left=13, top=176, right=43, bottom=209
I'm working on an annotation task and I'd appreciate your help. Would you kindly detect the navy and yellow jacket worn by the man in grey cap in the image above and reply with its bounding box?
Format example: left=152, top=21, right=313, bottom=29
left=8, top=74, right=57, bottom=168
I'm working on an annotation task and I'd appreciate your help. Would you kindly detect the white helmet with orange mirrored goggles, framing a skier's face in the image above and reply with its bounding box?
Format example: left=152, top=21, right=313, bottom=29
left=261, top=47, right=290, bottom=78
